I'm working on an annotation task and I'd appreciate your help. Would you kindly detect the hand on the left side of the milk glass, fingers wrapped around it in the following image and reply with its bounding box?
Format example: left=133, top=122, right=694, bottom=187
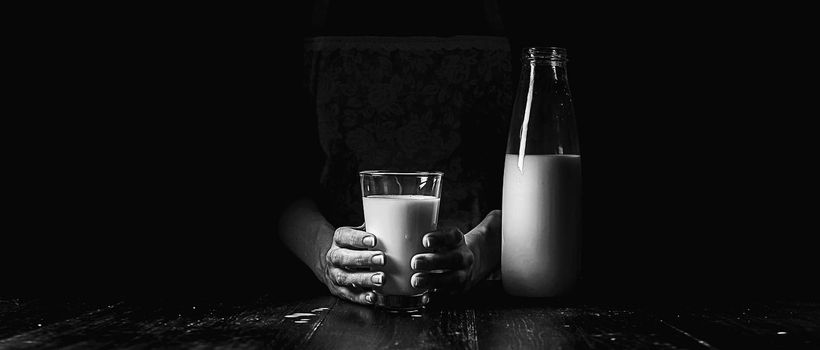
left=322, top=225, right=385, bottom=304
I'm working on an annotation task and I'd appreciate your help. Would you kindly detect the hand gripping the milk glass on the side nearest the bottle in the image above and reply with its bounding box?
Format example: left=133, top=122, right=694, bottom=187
left=410, top=210, right=501, bottom=293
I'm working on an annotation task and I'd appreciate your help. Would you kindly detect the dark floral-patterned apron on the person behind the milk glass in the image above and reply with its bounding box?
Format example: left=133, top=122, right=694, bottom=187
left=305, top=36, right=514, bottom=232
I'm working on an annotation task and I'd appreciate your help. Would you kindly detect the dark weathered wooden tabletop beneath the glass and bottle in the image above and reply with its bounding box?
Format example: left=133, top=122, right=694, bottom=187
left=0, top=282, right=820, bottom=350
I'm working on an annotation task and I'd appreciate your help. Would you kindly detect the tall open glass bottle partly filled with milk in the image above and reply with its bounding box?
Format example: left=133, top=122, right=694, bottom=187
left=501, top=47, right=581, bottom=297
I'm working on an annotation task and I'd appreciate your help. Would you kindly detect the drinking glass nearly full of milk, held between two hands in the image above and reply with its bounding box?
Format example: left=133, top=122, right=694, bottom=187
left=359, top=170, right=444, bottom=310
